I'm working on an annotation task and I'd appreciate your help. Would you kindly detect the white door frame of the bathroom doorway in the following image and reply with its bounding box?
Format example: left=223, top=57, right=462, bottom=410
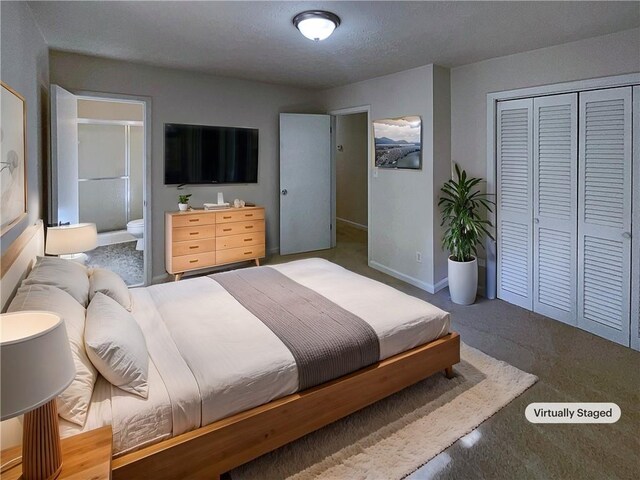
left=69, top=90, right=153, bottom=286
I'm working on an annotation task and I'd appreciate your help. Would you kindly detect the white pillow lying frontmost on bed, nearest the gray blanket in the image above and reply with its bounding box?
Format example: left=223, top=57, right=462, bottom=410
left=84, top=292, right=149, bottom=398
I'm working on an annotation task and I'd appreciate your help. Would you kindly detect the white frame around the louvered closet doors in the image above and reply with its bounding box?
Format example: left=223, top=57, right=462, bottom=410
left=485, top=73, right=640, bottom=299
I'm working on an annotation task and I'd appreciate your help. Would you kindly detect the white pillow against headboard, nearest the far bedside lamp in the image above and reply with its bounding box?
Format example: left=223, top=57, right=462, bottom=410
left=22, top=257, right=89, bottom=307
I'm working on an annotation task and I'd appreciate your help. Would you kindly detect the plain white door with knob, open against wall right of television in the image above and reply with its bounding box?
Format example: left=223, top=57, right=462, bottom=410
left=280, top=113, right=331, bottom=255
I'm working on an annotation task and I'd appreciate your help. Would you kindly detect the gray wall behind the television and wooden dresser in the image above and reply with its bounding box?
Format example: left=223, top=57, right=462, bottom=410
left=49, top=51, right=313, bottom=277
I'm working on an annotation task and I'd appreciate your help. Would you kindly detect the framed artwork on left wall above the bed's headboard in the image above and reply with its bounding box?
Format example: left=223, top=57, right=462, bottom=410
left=0, top=82, right=27, bottom=235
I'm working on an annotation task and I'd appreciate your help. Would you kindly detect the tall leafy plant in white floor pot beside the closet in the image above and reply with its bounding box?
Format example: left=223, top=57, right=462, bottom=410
left=438, top=165, right=494, bottom=305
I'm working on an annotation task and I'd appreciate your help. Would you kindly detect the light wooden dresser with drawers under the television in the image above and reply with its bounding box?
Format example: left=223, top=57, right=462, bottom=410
left=164, top=207, right=265, bottom=281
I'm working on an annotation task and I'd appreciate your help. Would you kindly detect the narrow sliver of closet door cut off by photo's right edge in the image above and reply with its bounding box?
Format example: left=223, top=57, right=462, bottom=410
left=631, top=86, right=640, bottom=350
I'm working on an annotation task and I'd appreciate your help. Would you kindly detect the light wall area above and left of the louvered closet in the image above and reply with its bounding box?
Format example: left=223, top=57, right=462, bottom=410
left=451, top=28, right=640, bottom=182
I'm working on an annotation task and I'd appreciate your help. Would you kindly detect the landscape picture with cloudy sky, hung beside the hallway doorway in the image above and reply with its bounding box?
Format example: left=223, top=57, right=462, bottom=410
left=373, top=115, right=422, bottom=170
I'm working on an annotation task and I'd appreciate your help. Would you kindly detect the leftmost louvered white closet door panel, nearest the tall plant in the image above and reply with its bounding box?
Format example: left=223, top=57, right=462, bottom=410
left=496, top=99, right=533, bottom=310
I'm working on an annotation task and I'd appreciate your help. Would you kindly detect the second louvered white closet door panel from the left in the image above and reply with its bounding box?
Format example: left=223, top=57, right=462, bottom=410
left=533, top=93, right=578, bottom=325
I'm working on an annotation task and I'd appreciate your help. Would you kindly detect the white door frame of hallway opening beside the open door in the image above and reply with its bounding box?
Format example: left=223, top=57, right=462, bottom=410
left=329, top=105, right=373, bottom=266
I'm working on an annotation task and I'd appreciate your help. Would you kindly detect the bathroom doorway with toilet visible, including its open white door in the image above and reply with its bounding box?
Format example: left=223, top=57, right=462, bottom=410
left=50, top=86, right=151, bottom=286
